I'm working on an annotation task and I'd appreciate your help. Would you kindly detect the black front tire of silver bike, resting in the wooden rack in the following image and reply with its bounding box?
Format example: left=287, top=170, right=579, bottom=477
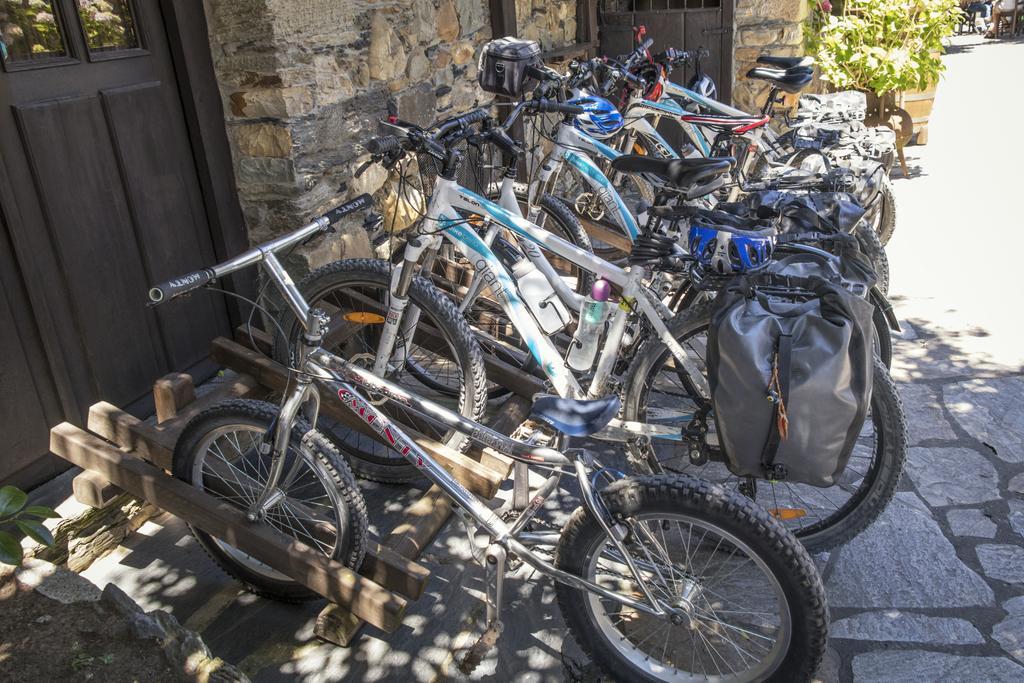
left=172, top=399, right=369, bottom=602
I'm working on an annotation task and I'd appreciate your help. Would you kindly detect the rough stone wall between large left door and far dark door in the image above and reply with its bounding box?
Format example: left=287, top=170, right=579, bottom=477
left=204, top=0, right=575, bottom=267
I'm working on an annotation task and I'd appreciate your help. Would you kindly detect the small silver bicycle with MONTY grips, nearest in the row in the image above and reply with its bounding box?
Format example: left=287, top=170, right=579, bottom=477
left=150, top=197, right=827, bottom=681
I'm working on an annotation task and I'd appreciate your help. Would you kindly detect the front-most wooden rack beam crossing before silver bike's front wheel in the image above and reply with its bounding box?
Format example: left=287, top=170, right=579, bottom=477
left=50, top=422, right=407, bottom=632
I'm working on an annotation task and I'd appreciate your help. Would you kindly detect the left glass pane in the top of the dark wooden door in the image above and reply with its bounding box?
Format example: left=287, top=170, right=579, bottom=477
left=0, top=0, right=68, bottom=65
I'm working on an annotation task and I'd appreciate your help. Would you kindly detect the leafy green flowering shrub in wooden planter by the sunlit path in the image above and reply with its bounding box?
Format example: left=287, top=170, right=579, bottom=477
left=807, top=0, right=961, bottom=143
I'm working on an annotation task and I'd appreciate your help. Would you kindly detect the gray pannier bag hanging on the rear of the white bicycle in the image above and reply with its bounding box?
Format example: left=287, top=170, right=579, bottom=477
left=707, top=259, right=873, bottom=486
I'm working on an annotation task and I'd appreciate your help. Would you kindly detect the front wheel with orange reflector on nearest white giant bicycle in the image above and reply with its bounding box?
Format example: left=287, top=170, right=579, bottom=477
left=273, top=259, right=486, bottom=483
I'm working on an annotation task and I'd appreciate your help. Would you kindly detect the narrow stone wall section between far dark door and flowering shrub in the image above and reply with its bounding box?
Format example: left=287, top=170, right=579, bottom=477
left=732, top=0, right=809, bottom=112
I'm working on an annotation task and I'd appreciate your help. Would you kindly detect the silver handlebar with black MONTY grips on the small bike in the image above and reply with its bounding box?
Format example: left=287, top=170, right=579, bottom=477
left=150, top=194, right=376, bottom=305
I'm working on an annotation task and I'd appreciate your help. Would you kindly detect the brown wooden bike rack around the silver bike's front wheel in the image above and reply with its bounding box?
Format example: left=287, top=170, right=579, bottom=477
left=50, top=333, right=529, bottom=645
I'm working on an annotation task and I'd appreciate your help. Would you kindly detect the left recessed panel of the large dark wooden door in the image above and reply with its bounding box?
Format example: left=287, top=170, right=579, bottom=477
left=14, top=96, right=167, bottom=402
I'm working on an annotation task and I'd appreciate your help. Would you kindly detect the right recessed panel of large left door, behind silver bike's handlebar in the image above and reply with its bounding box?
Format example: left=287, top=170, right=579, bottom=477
left=100, top=83, right=225, bottom=368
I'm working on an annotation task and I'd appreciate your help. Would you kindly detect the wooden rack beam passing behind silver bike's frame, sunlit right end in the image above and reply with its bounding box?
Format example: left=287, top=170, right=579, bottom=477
left=211, top=337, right=505, bottom=498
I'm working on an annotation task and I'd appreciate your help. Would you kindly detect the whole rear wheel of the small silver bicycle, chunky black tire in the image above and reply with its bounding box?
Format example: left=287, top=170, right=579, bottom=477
left=555, top=476, right=828, bottom=681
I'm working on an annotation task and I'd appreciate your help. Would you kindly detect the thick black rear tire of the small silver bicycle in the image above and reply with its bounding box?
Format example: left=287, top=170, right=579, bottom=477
left=555, top=476, right=828, bottom=682
